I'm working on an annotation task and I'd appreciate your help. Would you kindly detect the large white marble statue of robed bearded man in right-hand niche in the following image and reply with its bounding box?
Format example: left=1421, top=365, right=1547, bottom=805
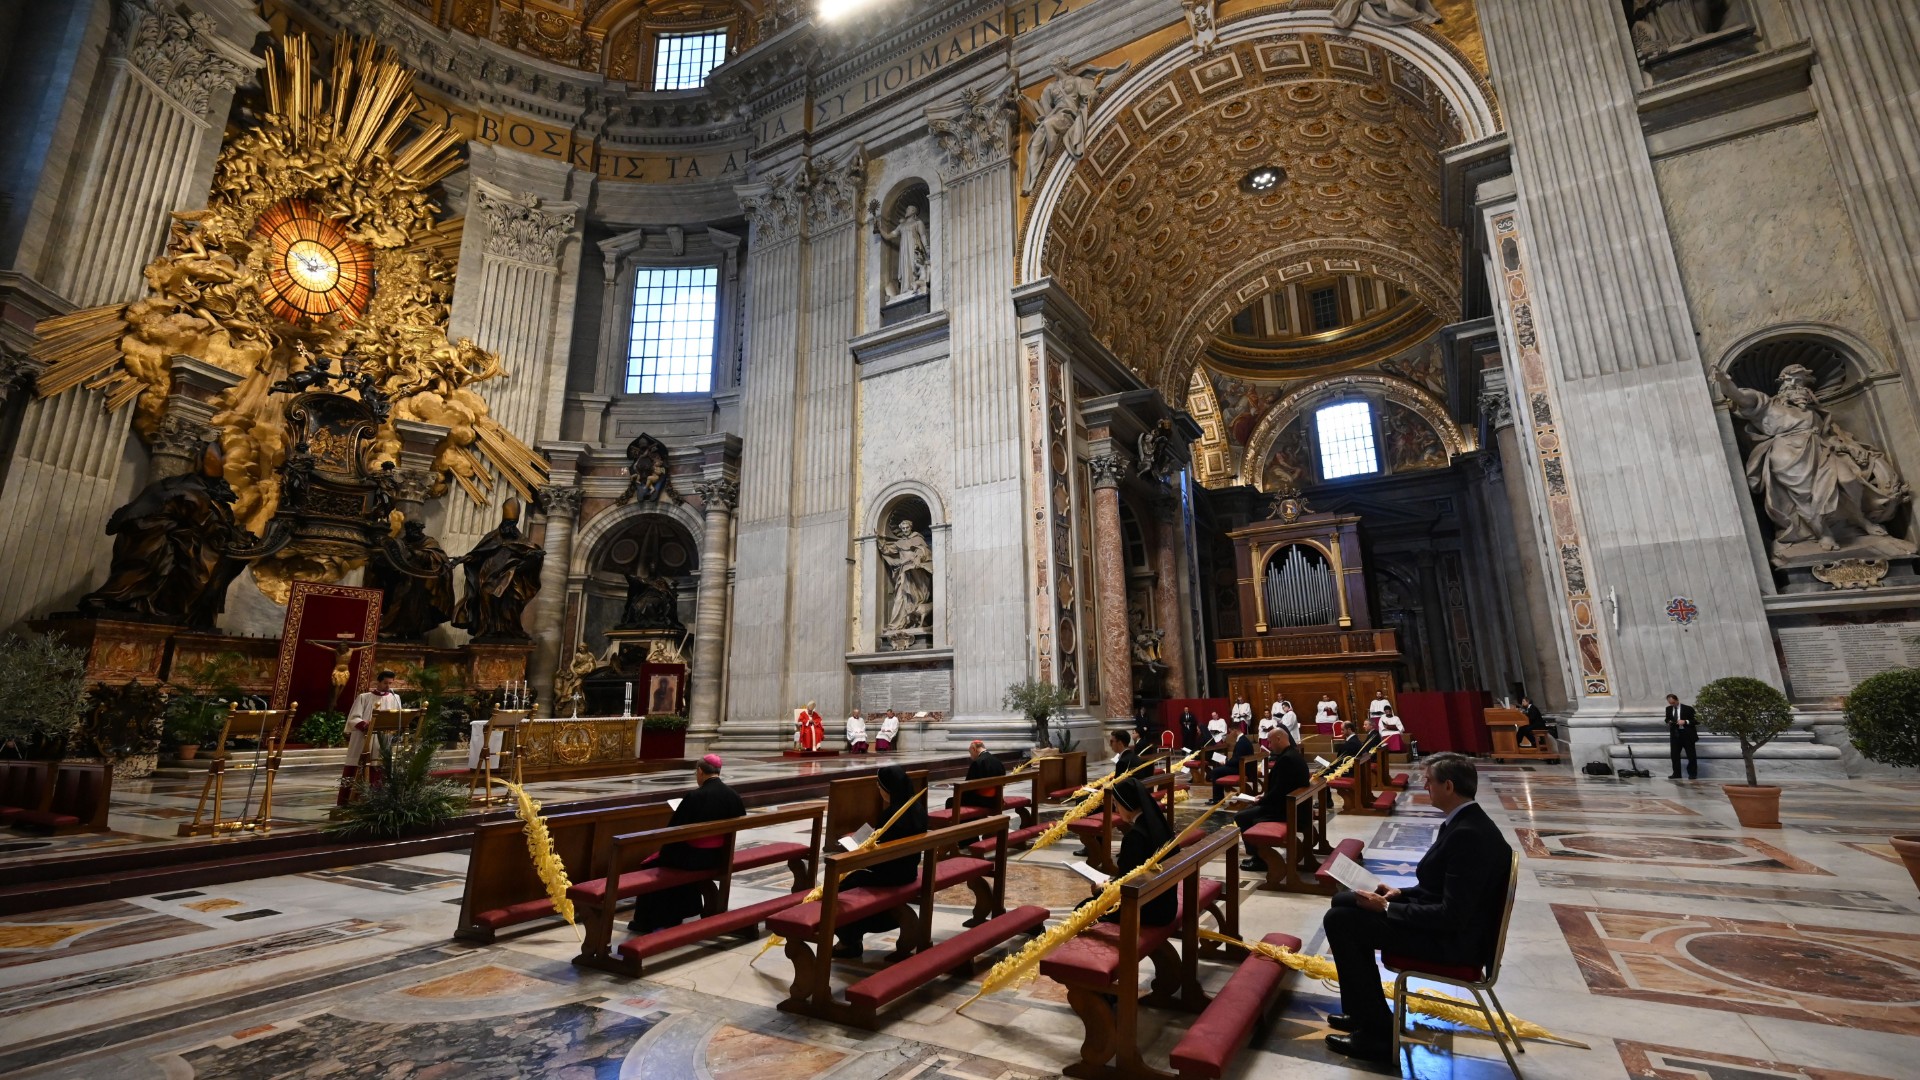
left=1713, top=363, right=1914, bottom=565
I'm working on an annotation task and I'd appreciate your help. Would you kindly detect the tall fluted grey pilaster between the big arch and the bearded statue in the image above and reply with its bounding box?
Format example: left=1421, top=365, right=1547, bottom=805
left=1480, top=0, right=1780, bottom=726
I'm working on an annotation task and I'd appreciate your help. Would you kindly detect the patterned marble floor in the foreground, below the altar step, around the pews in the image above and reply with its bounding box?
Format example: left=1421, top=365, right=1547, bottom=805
left=0, top=767, right=1920, bottom=1080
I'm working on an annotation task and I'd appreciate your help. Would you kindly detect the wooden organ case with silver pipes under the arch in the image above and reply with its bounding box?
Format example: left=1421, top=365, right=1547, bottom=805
left=1213, top=496, right=1400, bottom=732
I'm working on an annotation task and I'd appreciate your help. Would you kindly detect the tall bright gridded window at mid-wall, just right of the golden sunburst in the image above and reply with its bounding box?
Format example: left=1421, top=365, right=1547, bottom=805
left=626, top=267, right=720, bottom=394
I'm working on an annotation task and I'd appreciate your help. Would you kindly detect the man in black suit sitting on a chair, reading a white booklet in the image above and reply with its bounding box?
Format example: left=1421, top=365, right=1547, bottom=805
left=1321, top=753, right=1513, bottom=1063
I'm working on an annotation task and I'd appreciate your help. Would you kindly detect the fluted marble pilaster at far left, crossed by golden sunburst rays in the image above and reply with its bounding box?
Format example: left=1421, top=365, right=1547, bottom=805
left=0, top=4, right=265, bottom=626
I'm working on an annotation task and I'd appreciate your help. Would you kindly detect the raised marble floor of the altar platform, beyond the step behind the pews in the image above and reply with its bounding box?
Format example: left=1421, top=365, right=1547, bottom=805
left=0, top=749, right=964, bottom=867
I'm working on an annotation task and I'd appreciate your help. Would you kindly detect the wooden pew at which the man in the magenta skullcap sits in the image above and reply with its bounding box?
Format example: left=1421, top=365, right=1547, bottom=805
left=566, top=803, right=826, bottom=976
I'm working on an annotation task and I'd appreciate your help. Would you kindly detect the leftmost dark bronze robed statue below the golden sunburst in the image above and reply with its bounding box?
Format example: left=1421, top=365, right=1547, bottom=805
left=79, top=444, right=253, bottom=630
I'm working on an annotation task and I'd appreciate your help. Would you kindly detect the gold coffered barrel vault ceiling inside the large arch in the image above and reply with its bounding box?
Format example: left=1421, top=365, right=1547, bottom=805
left=1043, top=33, right=1459, bottom=402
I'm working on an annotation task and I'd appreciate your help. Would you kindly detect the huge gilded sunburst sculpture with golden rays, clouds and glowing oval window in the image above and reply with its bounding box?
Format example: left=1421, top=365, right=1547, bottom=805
left=36, top=35, right=547, bottom=596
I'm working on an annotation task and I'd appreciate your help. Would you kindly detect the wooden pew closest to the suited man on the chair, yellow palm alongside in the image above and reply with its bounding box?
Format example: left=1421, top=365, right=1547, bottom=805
left=1041, top=826, right=1240, bottom=1080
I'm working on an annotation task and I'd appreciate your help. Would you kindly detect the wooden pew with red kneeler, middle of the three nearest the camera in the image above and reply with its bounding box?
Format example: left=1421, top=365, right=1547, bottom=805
left=766, top=817, right=1046, bottom=1028
